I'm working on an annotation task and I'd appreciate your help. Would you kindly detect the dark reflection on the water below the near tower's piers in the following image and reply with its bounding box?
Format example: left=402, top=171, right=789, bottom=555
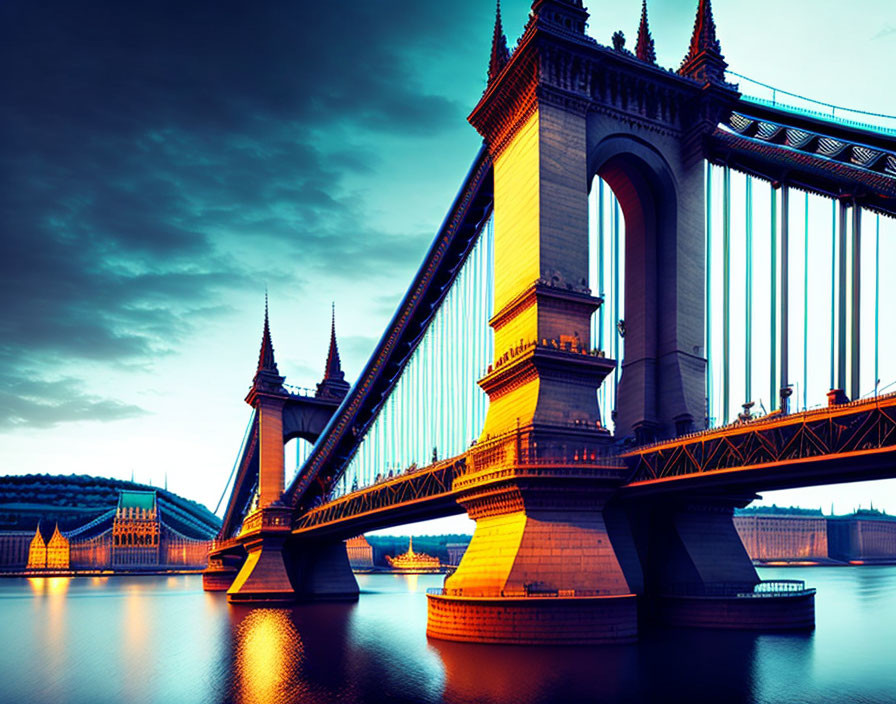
left=430, top=630, right=812, bottom=704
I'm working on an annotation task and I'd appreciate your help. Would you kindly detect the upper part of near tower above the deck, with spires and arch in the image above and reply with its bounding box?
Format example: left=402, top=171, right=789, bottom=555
left=469, top=0, right=737, bottom=442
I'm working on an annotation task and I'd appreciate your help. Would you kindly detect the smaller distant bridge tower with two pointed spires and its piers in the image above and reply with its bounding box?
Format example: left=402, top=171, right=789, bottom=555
left=211, top=296, right=358, bottom=603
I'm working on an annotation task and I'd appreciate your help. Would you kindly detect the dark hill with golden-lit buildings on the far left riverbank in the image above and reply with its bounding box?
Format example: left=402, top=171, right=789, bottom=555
left=0, top=474, right=220, bottom=572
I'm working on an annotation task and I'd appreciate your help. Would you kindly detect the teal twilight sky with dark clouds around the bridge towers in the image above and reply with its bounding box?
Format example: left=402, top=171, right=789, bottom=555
left=0, top=0, right=896, bottom=528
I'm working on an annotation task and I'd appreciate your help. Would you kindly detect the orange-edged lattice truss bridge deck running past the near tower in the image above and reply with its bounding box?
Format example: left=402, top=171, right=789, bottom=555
left=292, top=394, right=896, bottom=537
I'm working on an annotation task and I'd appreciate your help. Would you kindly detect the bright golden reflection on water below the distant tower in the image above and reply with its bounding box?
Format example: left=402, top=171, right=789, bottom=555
left=236, top=609, right=304, bottom=704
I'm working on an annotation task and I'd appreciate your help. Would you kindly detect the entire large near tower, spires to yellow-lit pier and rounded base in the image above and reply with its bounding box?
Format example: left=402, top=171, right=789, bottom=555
left=428, top=0, right=737, bottom=642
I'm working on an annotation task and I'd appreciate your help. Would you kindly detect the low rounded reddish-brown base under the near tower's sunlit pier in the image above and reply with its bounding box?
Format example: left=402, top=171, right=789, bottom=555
left=426, top=594, right=638, bottom=645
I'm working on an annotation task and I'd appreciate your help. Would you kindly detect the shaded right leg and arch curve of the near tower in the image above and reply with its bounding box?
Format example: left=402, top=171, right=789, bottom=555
left=587, top=133, right=706, bottom=444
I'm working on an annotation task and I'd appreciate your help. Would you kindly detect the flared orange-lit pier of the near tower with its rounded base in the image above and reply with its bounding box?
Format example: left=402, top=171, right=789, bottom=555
left=426, top=448, right=641, bottom=644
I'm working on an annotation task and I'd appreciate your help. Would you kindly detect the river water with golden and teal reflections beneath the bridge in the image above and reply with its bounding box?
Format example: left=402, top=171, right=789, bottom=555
left=0, top=566, right=896, bottom=704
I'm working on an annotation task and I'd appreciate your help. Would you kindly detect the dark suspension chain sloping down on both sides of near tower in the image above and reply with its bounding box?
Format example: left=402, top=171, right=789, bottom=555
left=282, top=96, right=896, bottom=527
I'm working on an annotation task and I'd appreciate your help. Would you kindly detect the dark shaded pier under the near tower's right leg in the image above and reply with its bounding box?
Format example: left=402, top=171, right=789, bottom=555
left=640, top=496, right=815, bottom=630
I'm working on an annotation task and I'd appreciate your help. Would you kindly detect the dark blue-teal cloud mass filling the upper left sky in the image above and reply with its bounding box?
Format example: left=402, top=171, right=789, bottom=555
left=0, top=0, right=496, bottom=427
